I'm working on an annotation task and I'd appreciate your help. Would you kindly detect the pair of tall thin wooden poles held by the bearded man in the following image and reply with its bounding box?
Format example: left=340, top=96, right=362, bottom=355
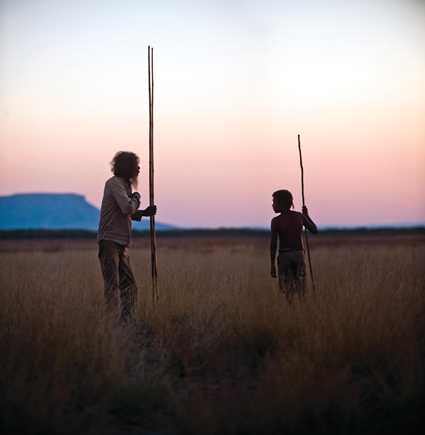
left=148, top=47, right=159, bottom=303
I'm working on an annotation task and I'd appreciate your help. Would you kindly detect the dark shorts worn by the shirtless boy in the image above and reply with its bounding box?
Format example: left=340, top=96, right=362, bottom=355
left=277, top=249, right=306, bottom=295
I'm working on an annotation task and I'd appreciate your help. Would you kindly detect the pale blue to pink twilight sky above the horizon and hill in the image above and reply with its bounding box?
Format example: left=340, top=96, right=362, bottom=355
left=0, top=0, right=425, bottom=227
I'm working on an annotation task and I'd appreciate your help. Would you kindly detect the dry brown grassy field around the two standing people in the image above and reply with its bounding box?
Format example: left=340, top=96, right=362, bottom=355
left=0, top=236, right=425, bottom=435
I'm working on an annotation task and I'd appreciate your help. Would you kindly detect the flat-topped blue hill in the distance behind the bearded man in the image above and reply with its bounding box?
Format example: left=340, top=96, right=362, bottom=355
left=0, top=193, right=176, bottom=231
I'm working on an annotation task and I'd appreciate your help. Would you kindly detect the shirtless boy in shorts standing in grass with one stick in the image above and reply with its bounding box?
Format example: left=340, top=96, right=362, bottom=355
left=270, top=190, right=319, bottom=302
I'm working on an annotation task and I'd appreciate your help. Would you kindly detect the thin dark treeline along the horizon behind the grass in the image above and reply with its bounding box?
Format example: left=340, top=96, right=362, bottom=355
left=0, top=226, right=425, bottom=240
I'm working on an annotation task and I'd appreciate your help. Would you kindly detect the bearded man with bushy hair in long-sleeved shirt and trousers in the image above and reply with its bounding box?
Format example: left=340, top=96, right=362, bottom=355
left=97, top=151, right=156, bottom=319
